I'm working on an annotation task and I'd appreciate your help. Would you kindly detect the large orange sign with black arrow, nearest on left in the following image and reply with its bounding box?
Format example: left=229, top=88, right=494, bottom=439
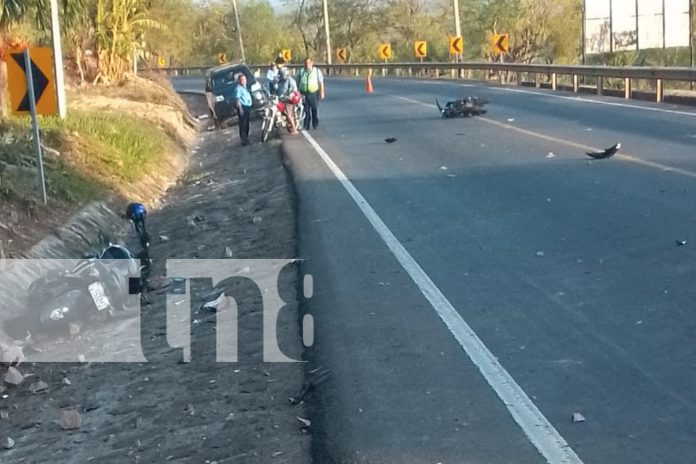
left=6, top=47, right=58, bottom=114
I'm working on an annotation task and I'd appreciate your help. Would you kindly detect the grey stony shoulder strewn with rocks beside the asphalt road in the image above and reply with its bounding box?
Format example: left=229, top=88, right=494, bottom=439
left=0, top=97, right=311, bottom=464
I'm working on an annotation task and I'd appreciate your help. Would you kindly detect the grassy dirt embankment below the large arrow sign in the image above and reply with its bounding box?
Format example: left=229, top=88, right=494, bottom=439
left=0, top=77, right=197, bottom=258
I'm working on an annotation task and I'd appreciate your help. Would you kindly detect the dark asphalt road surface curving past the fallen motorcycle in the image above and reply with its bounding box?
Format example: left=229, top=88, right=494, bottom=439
left=171, top=74, right=696, bottom=464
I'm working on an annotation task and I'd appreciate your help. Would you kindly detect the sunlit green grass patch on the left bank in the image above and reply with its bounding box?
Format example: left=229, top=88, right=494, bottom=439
left=0, top=110, right=172, bottom=203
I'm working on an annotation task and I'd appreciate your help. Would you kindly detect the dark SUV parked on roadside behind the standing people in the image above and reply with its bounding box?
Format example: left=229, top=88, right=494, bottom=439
left=205, top=63, right=268, bottom=128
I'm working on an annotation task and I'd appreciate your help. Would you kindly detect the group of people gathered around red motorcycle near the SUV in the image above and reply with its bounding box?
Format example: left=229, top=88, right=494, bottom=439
left=234, top=58, right=324, bottom=145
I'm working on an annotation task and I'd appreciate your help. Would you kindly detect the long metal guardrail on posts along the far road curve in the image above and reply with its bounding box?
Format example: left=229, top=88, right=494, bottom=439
left=160, top=61, right=696, bottom=102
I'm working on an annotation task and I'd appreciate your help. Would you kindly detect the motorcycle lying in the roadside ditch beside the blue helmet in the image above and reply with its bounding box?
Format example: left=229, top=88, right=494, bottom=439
left=5, top=244, right=149, bottom=339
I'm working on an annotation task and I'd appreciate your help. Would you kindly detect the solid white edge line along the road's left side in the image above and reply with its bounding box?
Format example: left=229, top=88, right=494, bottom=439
left=302, top=131, right=582, bottom=464
